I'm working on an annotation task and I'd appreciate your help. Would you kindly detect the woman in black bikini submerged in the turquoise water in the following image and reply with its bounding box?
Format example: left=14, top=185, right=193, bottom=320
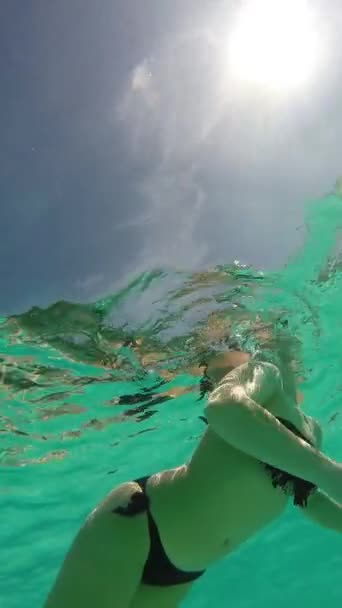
left=45, top=344, right=342, bottom=608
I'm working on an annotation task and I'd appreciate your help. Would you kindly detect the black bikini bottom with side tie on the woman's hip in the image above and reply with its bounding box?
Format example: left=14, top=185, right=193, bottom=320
left=113, top=476, right=205, bottom=587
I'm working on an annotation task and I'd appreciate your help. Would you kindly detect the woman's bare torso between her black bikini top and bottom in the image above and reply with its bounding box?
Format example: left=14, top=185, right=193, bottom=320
left=148, top=429, right=288, bottom=570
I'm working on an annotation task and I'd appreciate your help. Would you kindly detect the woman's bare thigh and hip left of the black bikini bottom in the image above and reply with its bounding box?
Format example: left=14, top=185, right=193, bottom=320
left=45, top=482, right=149, bottom=608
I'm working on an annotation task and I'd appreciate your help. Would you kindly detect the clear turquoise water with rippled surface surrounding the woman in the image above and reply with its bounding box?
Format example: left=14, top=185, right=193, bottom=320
left=0, top=195, right=342, bottom=608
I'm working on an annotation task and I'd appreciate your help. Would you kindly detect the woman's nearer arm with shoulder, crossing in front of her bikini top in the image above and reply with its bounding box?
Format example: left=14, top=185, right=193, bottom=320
left=206, top=363, right=342, bottom=502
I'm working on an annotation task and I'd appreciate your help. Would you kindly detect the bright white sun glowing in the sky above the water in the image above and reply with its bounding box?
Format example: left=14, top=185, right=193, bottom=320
left=228, top=0, right=318, bottom=91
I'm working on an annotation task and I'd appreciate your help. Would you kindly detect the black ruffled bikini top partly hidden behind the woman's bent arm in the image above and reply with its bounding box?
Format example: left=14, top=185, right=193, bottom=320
left=200, top=416, right=317, bottom=507
